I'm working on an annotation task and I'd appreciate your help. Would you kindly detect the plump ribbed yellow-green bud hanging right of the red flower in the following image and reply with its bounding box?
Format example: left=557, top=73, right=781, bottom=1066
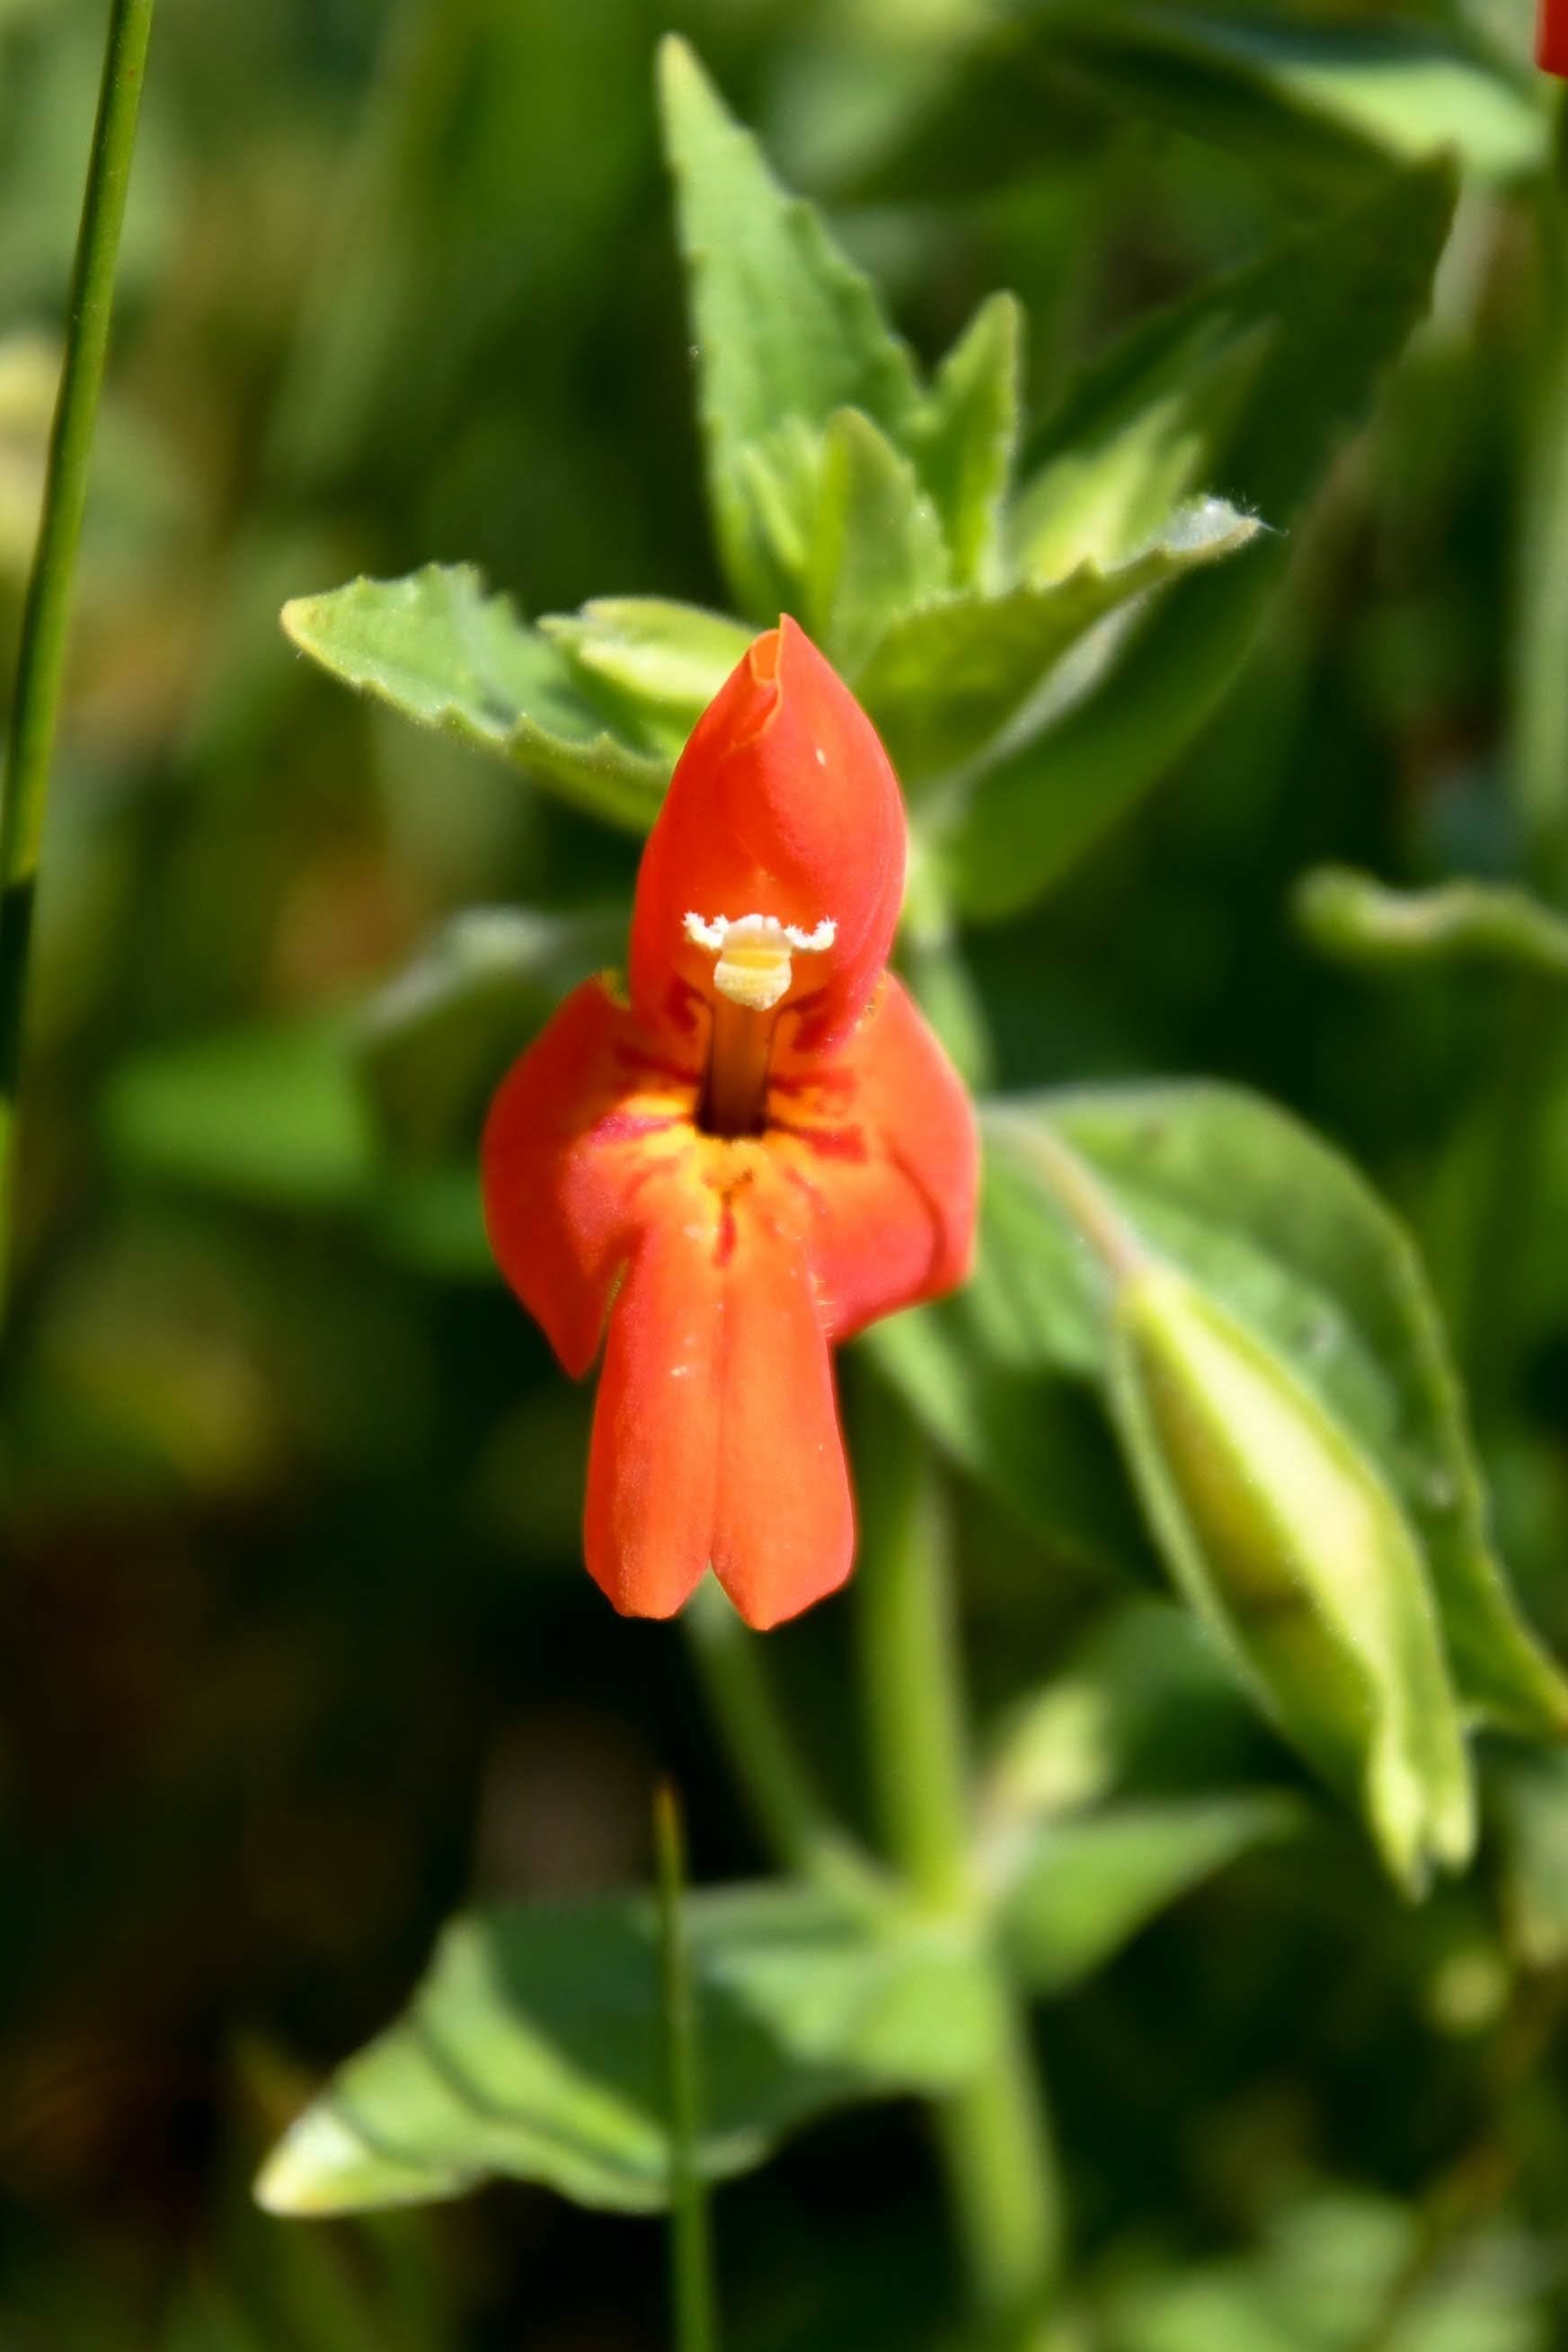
left=1112, top=1263, right=1474, bottom=1894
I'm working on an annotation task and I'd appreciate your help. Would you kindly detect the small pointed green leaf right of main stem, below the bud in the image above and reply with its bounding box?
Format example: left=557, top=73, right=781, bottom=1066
left=999, top=1792, right=1302, bottom=1994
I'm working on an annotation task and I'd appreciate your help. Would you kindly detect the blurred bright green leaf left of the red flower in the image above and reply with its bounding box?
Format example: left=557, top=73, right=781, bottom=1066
left=103, top=1018, right=374, bottom=1212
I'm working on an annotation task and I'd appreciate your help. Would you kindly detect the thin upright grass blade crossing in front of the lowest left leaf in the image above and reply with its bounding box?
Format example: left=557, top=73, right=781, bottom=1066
left=653, top=1780, right=717, bottom=2352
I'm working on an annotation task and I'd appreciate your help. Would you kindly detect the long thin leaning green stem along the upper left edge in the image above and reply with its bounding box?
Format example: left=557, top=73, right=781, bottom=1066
left=0, top=0, right=153, bottom=1310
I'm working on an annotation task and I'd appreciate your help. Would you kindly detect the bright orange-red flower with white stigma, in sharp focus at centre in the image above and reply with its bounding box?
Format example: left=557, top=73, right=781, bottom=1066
left=484, top=621, right=976, bottom=1625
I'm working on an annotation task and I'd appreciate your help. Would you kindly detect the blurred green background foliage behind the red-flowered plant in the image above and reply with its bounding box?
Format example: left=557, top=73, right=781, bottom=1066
left=0, top=0, right=1568, bottom=2352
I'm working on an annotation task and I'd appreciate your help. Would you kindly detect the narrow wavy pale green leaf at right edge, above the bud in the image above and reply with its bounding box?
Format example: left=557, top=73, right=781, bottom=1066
left=1296, top=865, right=1568, bottom=981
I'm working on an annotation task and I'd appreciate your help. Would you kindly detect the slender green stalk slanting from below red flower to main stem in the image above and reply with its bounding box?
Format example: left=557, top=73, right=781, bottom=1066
left=684, top=1578, right=879, bottom=1895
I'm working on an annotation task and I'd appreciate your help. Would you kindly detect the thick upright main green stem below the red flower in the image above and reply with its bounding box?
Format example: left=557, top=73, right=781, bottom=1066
left=855, top=1383, right=1063, bottom=2352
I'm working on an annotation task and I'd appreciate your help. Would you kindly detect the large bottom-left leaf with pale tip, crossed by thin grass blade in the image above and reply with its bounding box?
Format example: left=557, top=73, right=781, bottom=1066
left=259, top=1884, right=995, bottom=2214
